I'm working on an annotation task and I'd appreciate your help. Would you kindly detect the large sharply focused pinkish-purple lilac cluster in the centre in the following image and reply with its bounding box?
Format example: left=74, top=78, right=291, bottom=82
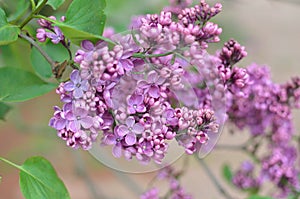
left=49, top=1, right=224, bottom=163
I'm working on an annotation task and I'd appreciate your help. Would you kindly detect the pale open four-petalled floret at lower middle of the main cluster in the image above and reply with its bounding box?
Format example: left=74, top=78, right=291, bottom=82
left=117, top=116, right=144, bottom=146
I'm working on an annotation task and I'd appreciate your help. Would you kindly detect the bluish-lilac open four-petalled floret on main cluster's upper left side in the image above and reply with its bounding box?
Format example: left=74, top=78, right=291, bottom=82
left=64, top=70, right=89, bottom=99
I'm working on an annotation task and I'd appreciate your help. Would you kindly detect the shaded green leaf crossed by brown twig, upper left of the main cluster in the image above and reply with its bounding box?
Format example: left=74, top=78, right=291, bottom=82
left=30, top=42, right=69, bottom=78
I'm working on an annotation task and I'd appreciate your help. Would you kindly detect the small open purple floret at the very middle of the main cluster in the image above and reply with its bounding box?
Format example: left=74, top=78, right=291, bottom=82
left=127, top=94, right=146, bottom=114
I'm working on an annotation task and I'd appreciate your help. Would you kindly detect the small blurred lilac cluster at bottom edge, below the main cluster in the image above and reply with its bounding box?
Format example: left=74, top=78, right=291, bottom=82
left=140, top=166, right=192, bottom=199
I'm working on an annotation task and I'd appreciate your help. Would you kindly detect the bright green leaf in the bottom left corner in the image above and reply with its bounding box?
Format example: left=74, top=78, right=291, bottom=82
left=20, top=157, right=70, bottom=199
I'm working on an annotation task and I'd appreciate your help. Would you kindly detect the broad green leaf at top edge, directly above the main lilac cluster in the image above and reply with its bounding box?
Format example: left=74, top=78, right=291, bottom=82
left=55, top=0, right=106, bottom=44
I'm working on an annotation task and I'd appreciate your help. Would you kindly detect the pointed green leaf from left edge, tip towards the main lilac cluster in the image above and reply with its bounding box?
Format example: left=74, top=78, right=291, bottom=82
left=0, top=67, right=57, bottom=102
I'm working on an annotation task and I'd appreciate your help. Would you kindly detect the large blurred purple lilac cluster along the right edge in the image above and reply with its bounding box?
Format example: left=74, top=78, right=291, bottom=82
left=228, top=58, right=300, bottom=198
